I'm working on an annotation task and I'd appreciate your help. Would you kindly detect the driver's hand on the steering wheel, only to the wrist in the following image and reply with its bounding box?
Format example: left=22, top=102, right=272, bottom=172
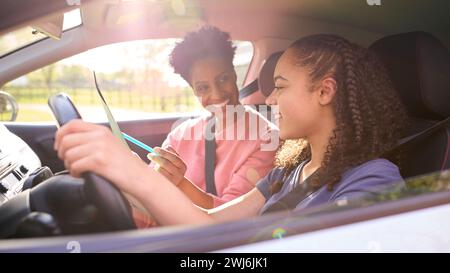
left=55, top=120, right=146, bottom=193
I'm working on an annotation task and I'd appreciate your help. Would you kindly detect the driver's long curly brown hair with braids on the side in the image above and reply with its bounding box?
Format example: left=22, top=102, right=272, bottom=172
left=272, top=34, right=408, bottom=192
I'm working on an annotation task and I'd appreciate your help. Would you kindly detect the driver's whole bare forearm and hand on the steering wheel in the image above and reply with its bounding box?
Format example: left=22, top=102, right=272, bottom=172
left=55, top=120, right=218, bottom=225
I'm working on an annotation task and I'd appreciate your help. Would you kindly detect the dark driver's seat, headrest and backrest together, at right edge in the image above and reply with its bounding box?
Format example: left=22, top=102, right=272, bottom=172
left=370, top=32, right=450, bottom=177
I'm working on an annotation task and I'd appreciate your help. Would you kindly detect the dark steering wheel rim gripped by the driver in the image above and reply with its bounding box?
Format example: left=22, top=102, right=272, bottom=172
left=48, top=93, right=136, bottom=230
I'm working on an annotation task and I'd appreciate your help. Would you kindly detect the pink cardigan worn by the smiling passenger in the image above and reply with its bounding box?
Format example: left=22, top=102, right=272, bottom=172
left=158, top=106, right=278, bottom=207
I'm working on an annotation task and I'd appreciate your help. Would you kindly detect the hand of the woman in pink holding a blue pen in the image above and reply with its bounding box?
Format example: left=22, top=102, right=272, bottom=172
left=147, top=146, right=186, bottom=186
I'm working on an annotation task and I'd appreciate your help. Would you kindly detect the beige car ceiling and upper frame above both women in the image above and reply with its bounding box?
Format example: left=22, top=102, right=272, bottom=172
left=0, top=0, right=450, bottom=86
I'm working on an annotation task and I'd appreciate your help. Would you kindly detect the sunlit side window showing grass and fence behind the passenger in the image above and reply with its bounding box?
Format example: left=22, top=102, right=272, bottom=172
left=2, top=39, right=253, bottom=122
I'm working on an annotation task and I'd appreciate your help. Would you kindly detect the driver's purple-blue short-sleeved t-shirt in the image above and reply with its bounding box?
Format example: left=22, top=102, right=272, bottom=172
left=256, top=159, right=404, bottom=214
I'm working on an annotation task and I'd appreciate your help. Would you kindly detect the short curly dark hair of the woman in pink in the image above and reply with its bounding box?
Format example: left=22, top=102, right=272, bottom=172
left=170, top=26, right=236, bottom=82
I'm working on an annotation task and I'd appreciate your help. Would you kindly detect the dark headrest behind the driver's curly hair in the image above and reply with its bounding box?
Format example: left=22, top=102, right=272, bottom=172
left=370, top=32, right=450, bottom=119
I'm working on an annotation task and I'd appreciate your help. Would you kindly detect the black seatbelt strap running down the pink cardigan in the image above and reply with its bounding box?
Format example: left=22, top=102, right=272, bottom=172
left=205, top=116, right=217, bottom=195
